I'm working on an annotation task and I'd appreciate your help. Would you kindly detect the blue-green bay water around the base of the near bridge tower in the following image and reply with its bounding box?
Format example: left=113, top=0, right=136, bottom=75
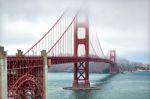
left=48, top=72, right=150, bottom=99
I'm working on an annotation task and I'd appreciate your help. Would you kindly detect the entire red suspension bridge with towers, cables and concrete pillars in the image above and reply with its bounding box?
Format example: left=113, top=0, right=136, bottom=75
left=0, top=11, right=118, bottom=99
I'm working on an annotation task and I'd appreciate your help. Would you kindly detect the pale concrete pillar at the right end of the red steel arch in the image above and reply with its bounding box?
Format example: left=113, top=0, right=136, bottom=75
left=41, top=50, right=48, bottom=99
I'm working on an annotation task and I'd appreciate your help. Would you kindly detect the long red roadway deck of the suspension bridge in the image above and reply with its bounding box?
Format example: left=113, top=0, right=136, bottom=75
left=7, top=56, right=115, bottom=67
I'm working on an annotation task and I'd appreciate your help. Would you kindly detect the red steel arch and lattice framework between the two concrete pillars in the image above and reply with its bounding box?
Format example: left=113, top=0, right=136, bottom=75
left=7, top=56, right=44, bottom=99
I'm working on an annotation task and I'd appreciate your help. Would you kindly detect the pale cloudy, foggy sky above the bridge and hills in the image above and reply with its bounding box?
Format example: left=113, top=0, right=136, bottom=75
left=0, top=0, right=150, bottom=63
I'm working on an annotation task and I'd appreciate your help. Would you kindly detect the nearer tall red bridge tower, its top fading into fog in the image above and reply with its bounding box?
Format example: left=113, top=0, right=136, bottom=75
left=72, top=18, right=90, bottom=88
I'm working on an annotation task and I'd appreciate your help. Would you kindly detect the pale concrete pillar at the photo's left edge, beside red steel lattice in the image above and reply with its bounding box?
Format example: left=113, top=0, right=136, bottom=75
left=0, top=47, right=7, bottom=99
